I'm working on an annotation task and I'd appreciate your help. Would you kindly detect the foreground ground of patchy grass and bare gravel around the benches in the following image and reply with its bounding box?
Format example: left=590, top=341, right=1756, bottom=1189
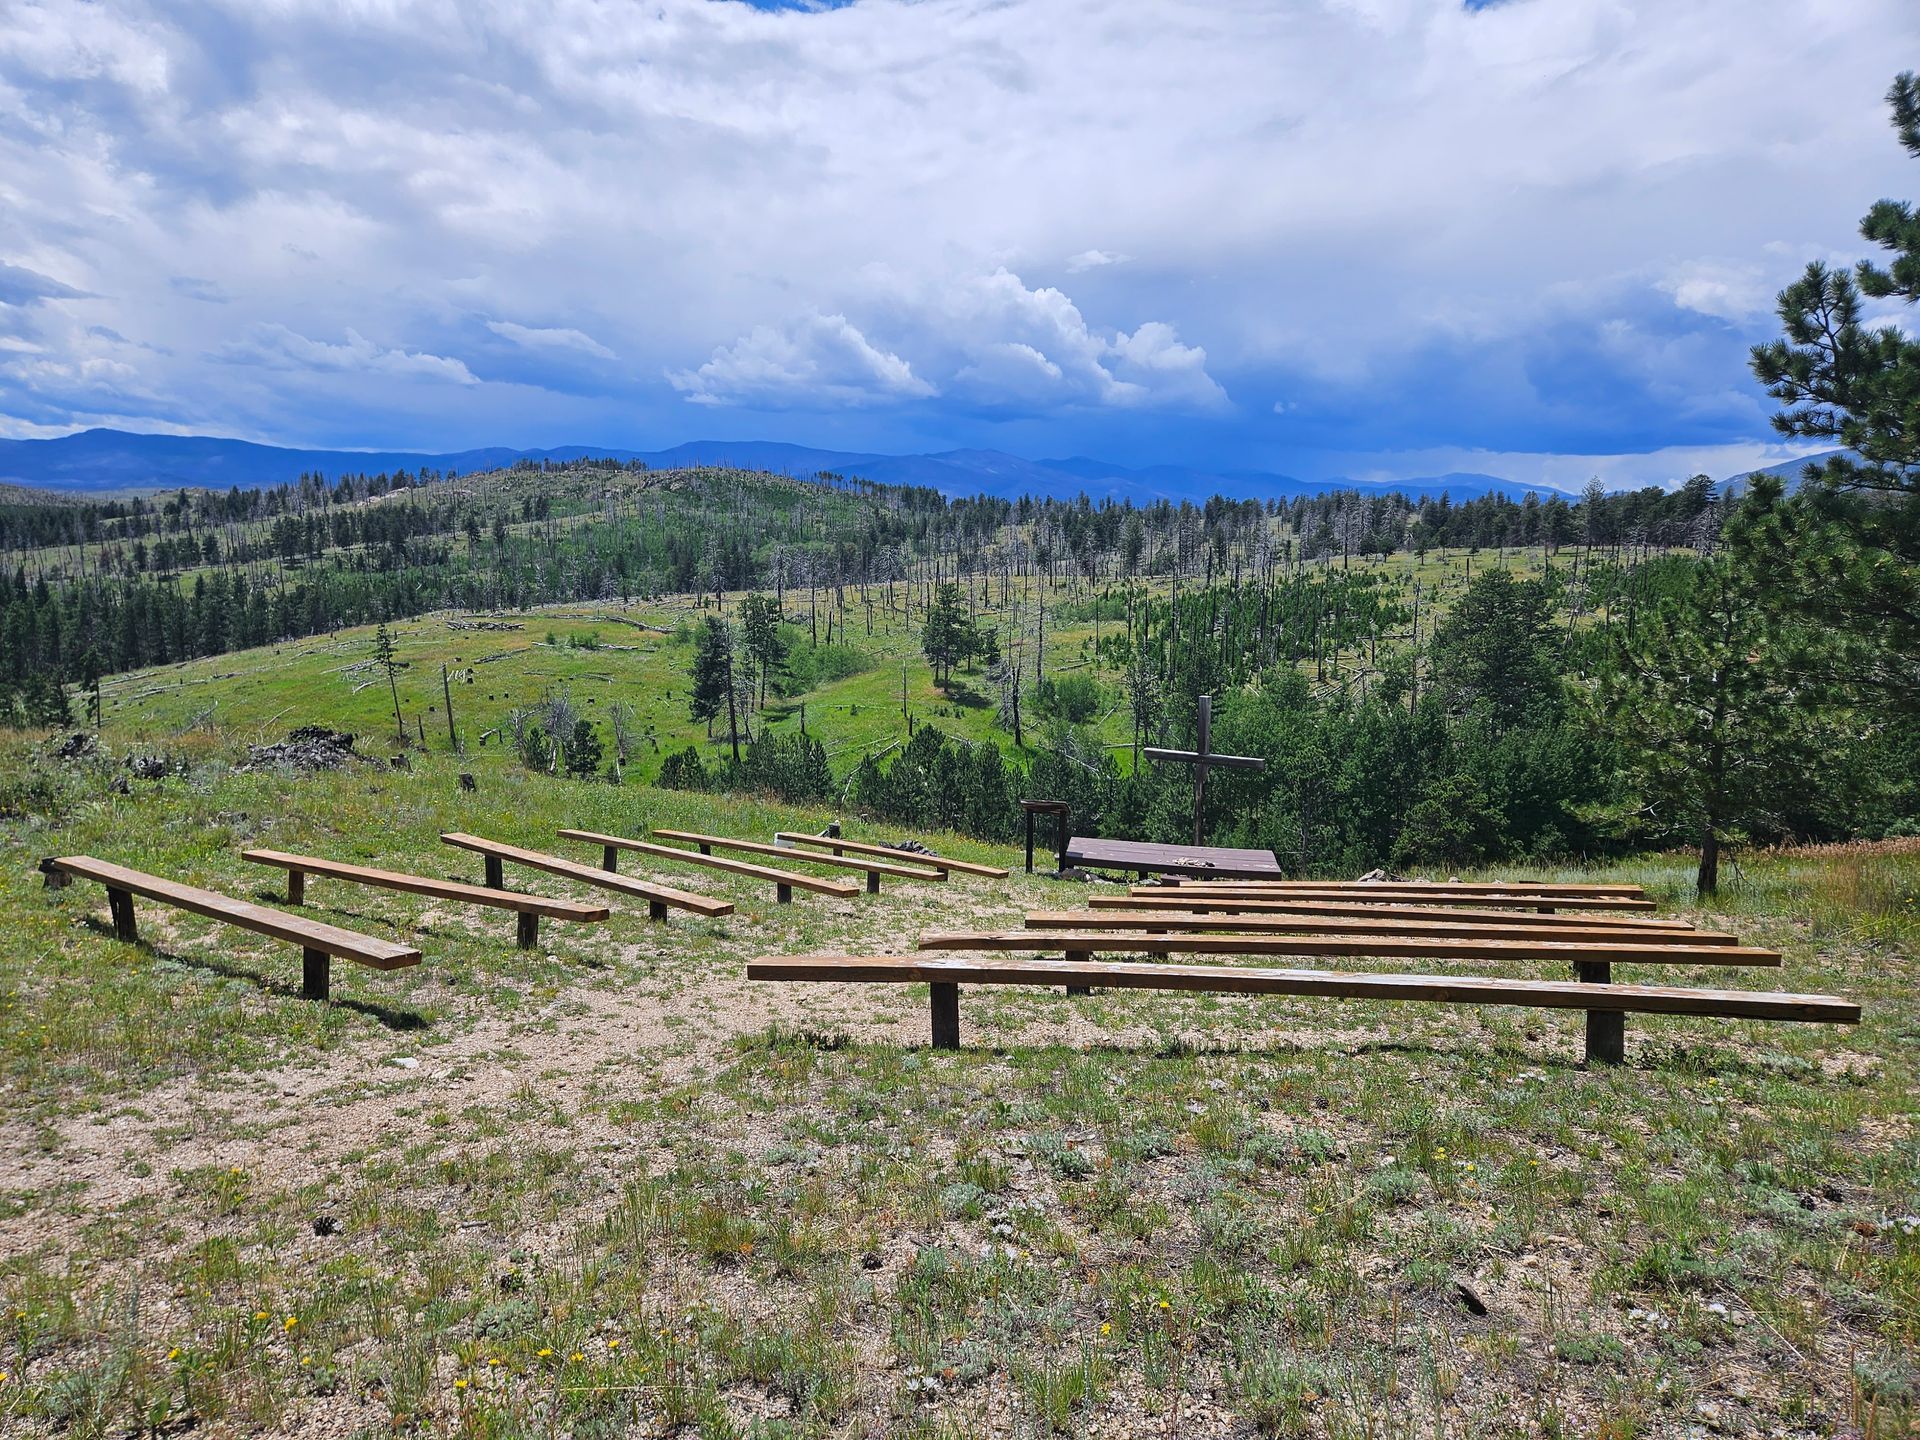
left=0, top=737, right=1920, bottom=1440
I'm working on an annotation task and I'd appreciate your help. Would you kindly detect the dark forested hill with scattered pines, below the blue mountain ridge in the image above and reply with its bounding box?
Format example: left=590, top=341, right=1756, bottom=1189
left=0, top=461, right=1715, bottom=695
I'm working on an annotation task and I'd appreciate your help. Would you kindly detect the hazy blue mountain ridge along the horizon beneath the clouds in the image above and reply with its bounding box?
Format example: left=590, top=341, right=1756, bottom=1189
left=0, top=430, right=1567, bottom=505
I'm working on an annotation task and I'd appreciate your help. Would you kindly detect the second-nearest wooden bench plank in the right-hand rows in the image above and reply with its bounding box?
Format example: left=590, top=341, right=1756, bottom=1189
left=920, top=929, right=1780, bottom=966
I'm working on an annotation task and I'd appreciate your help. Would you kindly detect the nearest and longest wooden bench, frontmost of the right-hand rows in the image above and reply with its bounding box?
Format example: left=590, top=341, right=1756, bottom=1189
left=747, top=954, right=1860, bottom=1064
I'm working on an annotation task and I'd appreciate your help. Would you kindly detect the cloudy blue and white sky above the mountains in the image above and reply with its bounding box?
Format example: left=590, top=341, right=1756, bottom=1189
left=0, top=0, right=1920, bottom=488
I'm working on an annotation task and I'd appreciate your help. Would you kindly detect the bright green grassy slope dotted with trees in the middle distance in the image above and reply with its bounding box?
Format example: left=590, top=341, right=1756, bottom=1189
left=93, top=553, right=1542, bottom=780
